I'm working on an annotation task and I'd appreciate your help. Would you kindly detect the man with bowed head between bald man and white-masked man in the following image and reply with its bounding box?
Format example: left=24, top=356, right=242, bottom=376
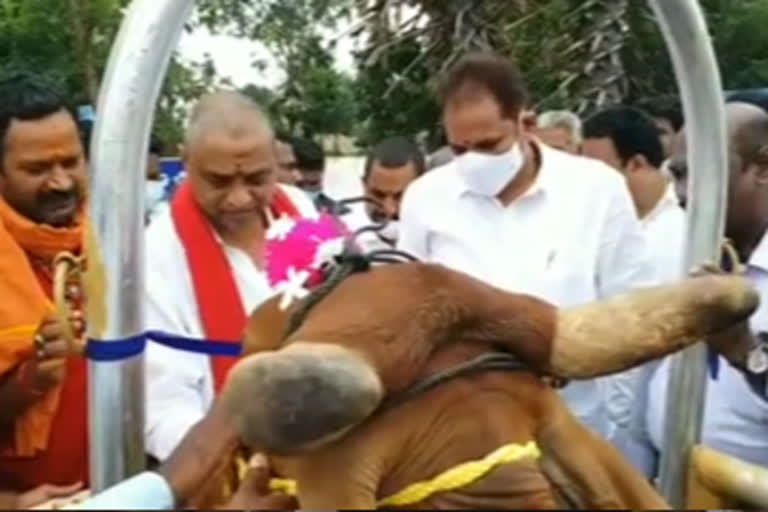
left=350, top=137, right=426, bottom=251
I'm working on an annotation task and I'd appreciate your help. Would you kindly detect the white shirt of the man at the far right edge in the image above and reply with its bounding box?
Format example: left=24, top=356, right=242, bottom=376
left=647, top=233, right=768, bottom=467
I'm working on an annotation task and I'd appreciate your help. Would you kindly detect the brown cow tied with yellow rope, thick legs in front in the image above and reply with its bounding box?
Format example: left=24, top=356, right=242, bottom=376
left=222, top=263, right=758, bottom=510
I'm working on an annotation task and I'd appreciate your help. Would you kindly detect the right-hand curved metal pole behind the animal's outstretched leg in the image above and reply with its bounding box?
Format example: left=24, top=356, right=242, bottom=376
left=650, top=0, right=728, bottom=508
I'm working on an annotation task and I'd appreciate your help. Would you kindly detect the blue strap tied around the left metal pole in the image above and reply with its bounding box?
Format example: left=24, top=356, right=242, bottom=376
left=85, top=331, right=243, bottom=362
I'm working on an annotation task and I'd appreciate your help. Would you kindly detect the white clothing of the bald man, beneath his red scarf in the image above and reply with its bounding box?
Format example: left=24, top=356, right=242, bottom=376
left=144, top=185, right=317, bottom=461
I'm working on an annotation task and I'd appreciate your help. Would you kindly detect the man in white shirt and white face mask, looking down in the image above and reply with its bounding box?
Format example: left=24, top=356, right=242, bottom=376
left=398, top=54, right=652, bottom=438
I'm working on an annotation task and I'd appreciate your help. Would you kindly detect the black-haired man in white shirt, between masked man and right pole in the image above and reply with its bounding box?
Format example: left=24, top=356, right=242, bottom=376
left=582, top=106, right=686, bottom=477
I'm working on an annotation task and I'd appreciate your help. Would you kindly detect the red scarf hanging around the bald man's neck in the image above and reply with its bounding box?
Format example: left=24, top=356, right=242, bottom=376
left=171, top=183, right=299, bottom=393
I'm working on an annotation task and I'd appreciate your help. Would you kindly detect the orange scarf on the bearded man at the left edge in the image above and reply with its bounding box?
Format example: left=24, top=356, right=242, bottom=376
left=0, top=199, right=85, bottom=457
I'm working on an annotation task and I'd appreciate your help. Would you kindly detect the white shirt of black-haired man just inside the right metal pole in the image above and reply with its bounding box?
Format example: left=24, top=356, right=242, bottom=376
left=613, top=183, right=686, bottom=478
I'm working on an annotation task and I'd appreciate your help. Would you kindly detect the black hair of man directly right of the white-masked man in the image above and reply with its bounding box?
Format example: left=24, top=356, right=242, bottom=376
left=583, top=106, right=664, bottom=168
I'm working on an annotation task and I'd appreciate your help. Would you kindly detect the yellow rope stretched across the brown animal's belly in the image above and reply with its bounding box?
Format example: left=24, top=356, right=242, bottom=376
left=269, top=441, right=541, bottom=507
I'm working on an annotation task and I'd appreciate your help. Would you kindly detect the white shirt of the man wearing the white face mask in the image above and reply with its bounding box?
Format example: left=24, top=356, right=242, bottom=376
left=398, top=145, right=652, bottom=437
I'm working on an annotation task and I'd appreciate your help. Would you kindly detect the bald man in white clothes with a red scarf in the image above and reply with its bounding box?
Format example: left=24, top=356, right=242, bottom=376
left=145, top=92, right=317, bottom=461
